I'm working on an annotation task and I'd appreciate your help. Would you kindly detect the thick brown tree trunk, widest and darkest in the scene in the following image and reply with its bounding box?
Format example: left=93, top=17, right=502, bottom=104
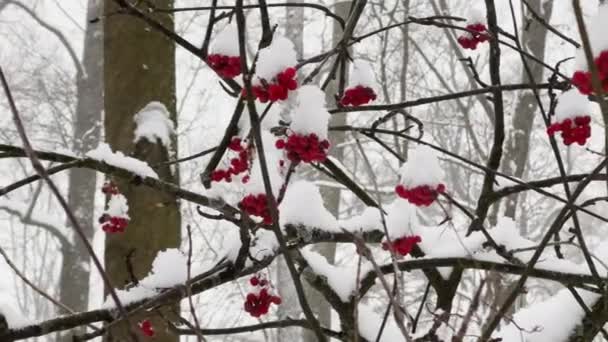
left=104, top=0, right=181, bottom=342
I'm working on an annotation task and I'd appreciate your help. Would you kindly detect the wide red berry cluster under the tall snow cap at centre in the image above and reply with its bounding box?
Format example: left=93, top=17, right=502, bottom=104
left=275, top=133, right=329, bottom=164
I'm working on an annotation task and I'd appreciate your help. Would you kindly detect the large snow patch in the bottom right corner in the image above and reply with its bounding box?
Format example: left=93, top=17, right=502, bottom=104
left=495, top=289, right=600, bottom=342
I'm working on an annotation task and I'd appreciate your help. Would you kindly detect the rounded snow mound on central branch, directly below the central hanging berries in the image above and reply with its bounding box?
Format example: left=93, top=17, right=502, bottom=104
left=279, top=180, right=340, bottom=232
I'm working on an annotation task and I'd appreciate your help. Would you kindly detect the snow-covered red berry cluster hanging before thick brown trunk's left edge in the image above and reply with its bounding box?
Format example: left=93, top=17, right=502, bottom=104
left=99, top=182, right=129, bottom=233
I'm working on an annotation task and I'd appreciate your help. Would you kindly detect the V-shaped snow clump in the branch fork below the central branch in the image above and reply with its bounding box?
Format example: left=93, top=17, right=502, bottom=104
left=302, top=248, right=372, bottom=303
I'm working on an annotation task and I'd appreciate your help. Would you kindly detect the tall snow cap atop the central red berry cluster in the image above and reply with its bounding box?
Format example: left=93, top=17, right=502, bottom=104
left=289, top=85, right=330, bottom=139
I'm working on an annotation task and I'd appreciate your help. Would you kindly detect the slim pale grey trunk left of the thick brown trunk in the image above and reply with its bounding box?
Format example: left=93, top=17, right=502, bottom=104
left=59, top=0, right=103, bottom=342
